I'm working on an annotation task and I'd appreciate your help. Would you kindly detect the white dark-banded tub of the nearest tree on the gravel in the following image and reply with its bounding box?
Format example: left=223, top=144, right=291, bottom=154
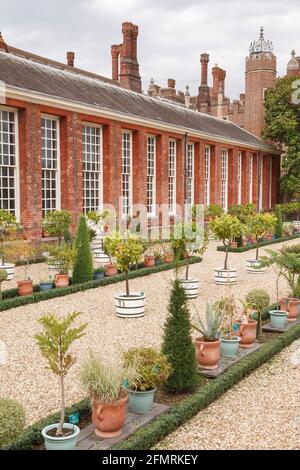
left=115, top=292, right=146, bottom=318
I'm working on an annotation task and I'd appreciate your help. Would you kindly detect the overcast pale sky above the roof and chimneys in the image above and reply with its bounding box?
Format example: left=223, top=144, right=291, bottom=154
left=0, top=0, right=300, bottom=98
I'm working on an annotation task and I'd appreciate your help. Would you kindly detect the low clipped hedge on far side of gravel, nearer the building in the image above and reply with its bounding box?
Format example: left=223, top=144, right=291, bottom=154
left=0, top=256, right=202, bottom=312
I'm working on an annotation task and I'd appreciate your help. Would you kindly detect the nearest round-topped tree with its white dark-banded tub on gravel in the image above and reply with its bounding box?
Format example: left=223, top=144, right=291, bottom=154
left=114, top=232, right=146, bottom=318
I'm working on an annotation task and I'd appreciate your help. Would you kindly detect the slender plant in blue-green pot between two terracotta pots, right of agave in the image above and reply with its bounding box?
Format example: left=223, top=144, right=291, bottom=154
left=216, top=294, right=241, bottom=357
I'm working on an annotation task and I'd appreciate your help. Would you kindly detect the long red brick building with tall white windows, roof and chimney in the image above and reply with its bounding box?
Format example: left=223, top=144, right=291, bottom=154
left=0, top=23, right=280, bottom=236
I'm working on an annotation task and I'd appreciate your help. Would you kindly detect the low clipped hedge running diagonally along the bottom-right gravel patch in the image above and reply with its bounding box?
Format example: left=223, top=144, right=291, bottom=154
left=112, top=324, right=300, bottom=450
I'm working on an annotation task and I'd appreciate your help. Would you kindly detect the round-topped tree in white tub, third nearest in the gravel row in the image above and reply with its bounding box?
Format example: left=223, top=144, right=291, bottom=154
left=210, top=215, right=243, bottom=285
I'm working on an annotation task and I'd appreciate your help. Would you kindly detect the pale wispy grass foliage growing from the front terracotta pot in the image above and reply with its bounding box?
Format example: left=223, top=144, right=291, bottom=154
left=80, top=352, right=137, bottom=403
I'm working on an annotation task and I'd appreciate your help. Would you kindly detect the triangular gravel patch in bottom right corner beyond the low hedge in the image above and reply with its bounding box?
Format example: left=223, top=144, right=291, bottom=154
left=156, top=340, right=300, bottom=450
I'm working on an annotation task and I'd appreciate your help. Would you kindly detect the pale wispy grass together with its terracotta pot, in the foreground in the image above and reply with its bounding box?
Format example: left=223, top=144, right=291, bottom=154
left=80, top=352, right=137, bottom=439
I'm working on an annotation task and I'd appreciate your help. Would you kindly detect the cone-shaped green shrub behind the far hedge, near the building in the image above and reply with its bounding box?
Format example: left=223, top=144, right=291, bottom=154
left=73, top=215, right=94, bottom=284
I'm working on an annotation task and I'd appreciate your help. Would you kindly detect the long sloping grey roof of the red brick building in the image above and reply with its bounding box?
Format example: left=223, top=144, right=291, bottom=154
left=0, top=48, right=276, bottom=151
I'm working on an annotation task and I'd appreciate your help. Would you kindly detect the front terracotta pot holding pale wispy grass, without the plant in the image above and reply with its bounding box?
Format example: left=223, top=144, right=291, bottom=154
left=92, top=396, right=128, bottom=439
